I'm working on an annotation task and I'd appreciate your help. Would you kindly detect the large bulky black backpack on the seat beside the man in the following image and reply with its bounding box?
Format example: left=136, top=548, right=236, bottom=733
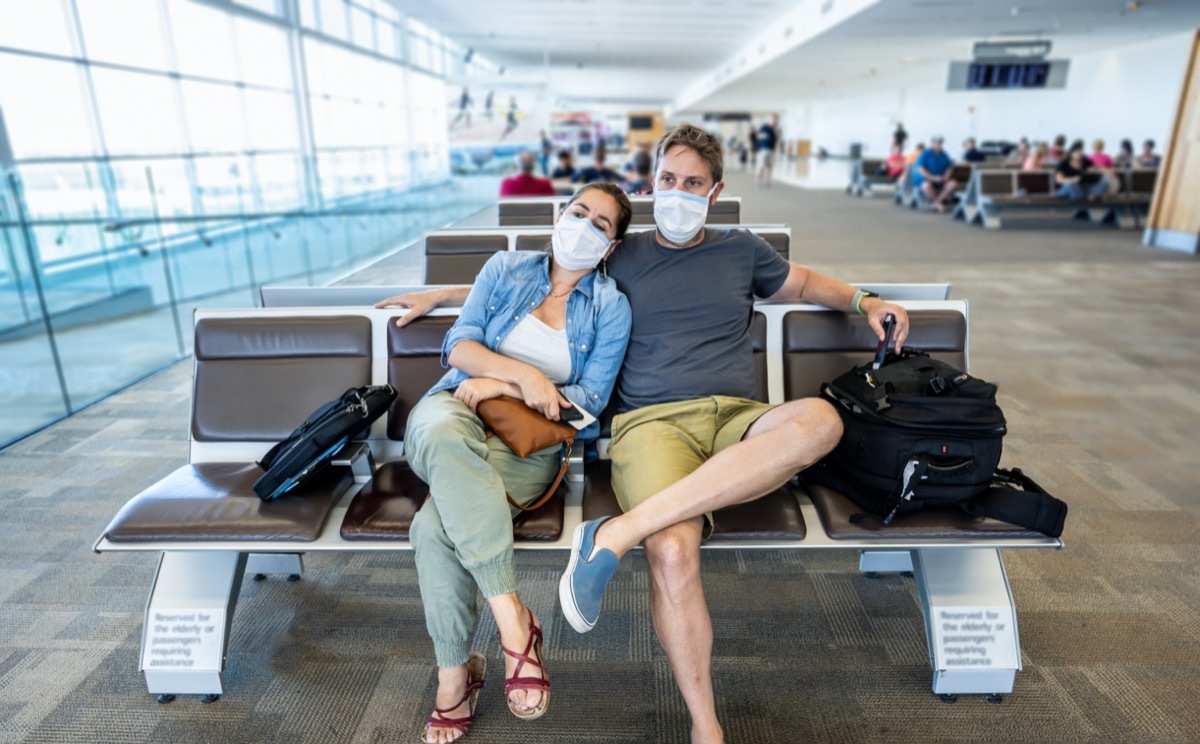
left=802, top=349, right=1067, bottom=536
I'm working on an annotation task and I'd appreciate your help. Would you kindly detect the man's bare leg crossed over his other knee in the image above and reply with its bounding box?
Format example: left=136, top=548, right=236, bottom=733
left=595, top=398, right=841, bottom=558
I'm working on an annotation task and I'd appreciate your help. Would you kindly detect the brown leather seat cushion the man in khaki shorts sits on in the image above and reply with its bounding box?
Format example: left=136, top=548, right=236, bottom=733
left=583, top=460, right=808, bottom=542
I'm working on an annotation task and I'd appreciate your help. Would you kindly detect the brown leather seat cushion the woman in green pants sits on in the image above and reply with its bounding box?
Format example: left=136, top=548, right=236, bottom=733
left=342, top=462, right=564, bottom=542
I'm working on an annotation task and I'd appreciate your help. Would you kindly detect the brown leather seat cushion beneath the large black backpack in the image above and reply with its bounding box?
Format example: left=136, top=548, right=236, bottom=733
left=805, top=484, right=1045, bottom=540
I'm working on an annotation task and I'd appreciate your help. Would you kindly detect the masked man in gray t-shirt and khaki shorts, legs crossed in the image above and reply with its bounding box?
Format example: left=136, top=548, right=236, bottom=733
left=377, top=125, right=908, bottom=743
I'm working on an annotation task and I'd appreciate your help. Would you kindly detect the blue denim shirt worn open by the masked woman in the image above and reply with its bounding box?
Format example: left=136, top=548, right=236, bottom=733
left=426, top=251, right=632, bottom=439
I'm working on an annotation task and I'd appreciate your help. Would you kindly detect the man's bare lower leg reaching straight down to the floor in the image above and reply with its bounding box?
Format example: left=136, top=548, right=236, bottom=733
left=646, top=517, right=724, bottom=744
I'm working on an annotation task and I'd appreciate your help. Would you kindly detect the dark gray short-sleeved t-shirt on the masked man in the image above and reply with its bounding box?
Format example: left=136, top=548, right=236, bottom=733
left=608, top=228, right=791, bottom=412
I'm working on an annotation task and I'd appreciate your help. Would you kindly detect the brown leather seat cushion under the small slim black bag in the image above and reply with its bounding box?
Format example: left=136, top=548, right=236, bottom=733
left=104, top=462, right=354, bottom=542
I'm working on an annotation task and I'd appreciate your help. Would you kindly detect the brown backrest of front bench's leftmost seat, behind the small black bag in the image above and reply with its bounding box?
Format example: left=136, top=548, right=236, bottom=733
left=192, top=316, right=371, bottom=442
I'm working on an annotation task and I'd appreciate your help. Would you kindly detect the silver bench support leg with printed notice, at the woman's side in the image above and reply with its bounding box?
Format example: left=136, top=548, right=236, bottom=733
left=138, top=551, right=246, bottom=700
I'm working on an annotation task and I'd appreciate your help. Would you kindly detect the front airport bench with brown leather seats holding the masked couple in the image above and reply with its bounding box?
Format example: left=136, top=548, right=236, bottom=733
left=96, top=301, right=1062, bottom=700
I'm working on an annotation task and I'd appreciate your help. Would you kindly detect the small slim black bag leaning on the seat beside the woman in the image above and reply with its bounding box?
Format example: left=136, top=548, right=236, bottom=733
left=253, top=385, right=396, bottom=502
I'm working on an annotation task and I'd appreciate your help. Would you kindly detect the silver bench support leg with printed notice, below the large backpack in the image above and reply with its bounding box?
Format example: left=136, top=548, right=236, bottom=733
left=912, top=548, right=1021, bottom=695
